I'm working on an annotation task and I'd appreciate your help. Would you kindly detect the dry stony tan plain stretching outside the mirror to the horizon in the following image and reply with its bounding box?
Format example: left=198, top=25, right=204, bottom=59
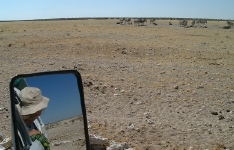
left=0, top=19, right=234, bottom=150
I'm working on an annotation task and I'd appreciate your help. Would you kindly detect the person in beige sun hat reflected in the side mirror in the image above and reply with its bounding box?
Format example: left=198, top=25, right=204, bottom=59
left=16, top=87, right=50, bottom=150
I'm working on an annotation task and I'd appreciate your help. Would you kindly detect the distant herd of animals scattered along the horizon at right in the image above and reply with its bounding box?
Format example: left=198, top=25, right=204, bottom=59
left=116, top=18, right=233, bottom=29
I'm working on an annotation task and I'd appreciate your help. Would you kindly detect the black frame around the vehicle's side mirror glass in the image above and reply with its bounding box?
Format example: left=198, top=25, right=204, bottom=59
left=9, top=70, right=90, bottom=150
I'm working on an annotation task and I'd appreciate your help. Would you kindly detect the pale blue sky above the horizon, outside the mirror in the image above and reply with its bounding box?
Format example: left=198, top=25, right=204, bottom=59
left=0, top=0, right=234, bottom=20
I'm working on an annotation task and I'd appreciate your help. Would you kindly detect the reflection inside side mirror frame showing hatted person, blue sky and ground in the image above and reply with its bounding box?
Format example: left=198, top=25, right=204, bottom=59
left=10, top=73, right=87, bottom=150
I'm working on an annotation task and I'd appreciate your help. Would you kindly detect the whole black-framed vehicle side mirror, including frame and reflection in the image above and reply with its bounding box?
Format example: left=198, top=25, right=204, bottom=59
left=10, top=70, right=89, bottom=150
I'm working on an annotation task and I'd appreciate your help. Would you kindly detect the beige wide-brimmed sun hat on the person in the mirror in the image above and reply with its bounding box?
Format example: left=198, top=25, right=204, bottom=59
left=17, top=87, right=49, bottom=115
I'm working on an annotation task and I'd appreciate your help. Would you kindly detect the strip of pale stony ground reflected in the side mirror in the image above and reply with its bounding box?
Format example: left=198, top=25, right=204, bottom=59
left=45, top=116, right=86, bottom=150
